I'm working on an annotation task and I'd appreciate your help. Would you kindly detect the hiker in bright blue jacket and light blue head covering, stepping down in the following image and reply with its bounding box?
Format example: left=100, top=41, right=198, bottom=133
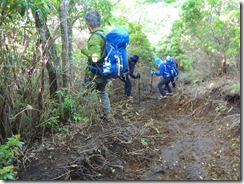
left=151, top=58, right=173, bottom=99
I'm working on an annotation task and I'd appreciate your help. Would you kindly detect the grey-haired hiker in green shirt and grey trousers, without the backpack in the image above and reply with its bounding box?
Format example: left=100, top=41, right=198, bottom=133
left=76, top=10, right=114, bottom=121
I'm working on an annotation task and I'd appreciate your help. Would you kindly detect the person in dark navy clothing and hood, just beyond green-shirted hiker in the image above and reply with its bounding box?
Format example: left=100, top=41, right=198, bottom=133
left=119, top=55, right=141, bottom=99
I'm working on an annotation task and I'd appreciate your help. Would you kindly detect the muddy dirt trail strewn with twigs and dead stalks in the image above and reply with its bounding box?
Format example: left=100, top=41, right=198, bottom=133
left=18, top=77, right=240, bottom=181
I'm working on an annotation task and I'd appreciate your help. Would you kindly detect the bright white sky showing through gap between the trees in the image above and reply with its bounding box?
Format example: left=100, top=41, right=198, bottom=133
left=112, top=0, right=178, bottom=44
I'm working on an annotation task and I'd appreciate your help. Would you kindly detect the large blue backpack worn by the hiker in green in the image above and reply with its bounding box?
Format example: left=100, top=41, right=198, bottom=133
left=88, top=28, right=129, bottom=79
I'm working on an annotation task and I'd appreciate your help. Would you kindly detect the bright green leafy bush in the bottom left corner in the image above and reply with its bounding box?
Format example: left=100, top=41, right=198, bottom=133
left=0, top=134, right=24, bottom=180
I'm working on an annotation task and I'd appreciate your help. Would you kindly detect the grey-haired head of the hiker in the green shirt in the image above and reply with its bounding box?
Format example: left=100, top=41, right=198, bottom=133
left=85, top=10, right=101, bottom=29
